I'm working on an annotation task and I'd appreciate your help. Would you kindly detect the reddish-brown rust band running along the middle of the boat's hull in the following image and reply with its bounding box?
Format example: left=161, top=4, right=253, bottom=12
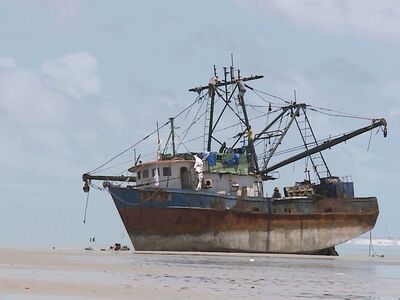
left=119, top=208, right=378, bottom=237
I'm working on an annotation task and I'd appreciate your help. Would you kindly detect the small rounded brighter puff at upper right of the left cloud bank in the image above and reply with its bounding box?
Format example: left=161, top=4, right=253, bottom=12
left=41, top=52, right=101, bottom=98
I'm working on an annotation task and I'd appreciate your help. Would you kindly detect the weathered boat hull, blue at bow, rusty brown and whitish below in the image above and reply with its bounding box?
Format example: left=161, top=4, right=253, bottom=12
left=109, top=187, right=379, bottom=253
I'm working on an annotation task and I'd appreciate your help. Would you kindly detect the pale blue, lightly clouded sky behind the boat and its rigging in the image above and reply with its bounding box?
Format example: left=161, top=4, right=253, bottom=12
left=0, top=0, right=400, bottom=248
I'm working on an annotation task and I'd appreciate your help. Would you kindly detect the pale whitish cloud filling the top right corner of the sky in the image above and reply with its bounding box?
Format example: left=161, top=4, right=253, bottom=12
left=242, top=0, right=400, bottom=36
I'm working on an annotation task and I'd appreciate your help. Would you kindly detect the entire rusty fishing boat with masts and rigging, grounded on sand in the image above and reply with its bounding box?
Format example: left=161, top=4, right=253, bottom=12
left=82, top=65, right=387, bottom=255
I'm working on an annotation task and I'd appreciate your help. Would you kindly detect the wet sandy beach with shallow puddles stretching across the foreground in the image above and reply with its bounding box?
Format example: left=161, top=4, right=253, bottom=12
left=0, top=249, right=400, bottom=300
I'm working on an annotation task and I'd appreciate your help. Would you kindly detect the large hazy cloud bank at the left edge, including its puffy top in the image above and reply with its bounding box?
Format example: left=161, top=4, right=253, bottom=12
left=0, top=52, right=109, bottom=184
